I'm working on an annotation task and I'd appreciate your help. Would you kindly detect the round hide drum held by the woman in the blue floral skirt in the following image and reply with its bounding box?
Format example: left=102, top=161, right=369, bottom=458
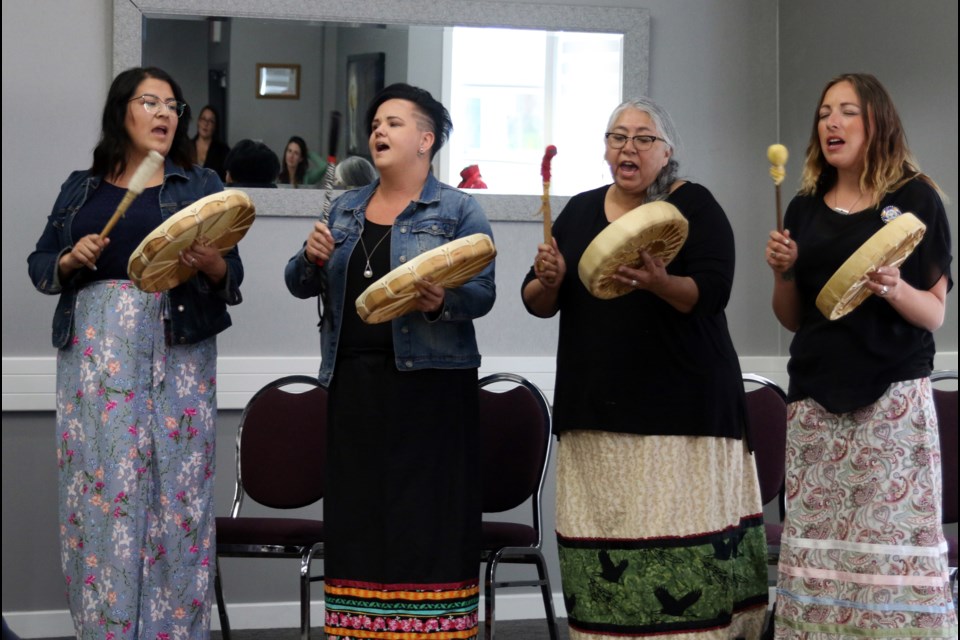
left=127, top=189, right=256, bottom=292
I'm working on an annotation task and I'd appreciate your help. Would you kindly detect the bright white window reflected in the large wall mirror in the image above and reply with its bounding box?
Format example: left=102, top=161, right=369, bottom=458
left=445, top=27, right=623, bottom=195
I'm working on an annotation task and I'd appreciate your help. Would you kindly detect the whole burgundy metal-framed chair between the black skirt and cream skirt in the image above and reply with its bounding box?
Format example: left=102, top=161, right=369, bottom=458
left=479, top=373, right=559, bottom=640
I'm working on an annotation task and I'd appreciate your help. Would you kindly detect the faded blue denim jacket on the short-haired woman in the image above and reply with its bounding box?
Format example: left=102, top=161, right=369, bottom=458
left=284, top=175, right=496, bottom=385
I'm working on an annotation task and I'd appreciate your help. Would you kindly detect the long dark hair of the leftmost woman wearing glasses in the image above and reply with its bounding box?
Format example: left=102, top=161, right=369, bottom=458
left=90, top=67, right=192, bottom=177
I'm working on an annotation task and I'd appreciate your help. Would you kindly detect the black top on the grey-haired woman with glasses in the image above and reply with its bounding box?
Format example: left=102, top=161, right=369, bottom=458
left=524, top=183, right=745, bottom=439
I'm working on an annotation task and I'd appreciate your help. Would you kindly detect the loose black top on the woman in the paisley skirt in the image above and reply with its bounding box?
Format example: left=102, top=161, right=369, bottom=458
left=784, top=180, right=953, bottom=413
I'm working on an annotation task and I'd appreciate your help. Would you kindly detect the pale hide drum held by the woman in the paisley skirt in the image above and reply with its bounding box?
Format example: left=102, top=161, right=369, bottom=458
left=817, top=213, right=927, bottom=320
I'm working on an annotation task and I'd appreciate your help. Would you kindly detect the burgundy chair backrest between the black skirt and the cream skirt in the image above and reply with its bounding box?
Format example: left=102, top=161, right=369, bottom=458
left=479, top=373, right=553, bottom=516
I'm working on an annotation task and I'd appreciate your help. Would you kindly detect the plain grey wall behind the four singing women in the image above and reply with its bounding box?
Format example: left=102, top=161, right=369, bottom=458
left=2, top=0, right=960, bottom=635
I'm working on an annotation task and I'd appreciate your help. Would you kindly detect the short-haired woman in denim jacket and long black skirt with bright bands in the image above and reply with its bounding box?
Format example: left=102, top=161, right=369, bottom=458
left=285, top=84, right=496, bottom=640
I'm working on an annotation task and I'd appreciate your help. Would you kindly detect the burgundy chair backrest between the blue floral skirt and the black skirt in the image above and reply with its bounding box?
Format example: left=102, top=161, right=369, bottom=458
left=231, top=375, right=327, bottom=517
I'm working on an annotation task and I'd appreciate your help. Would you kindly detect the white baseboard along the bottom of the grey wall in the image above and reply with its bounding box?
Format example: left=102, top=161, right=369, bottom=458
left=3, top=593, right=567, bottom=638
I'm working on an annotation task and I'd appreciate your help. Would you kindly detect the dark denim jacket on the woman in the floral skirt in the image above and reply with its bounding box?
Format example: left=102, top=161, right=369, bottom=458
left=27, top=160, right=243, bottom=349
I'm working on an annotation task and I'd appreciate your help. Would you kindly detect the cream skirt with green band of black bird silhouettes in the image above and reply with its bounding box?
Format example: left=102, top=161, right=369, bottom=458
left=557, top=431, right=768, bottom=640
